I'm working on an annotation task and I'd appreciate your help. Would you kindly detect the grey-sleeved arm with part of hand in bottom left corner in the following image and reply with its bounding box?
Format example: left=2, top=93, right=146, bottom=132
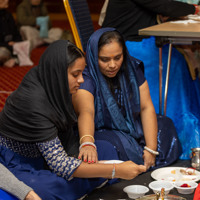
left=0, top=163, right=41, bottom=200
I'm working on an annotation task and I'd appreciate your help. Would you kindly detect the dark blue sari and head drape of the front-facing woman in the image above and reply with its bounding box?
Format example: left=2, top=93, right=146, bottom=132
left=80, top=28, right=180, bottom=167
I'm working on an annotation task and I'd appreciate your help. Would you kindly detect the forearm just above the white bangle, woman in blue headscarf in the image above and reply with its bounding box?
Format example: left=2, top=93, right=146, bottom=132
left=141, top=107, right=158, bottom=150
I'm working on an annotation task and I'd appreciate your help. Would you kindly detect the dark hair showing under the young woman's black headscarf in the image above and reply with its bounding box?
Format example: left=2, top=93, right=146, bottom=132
left=67, top=42, right=85, bottom=67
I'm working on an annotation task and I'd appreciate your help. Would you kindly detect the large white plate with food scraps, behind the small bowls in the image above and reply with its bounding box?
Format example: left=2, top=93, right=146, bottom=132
left=151, top=167, right=200, bottom=182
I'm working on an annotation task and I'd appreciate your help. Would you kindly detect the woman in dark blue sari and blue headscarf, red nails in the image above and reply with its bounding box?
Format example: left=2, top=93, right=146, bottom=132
left=72, top=28, right=180, bottom=169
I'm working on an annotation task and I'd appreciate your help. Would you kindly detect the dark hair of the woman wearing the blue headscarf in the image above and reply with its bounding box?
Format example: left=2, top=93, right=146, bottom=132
left=98, top=31, right=126, bottom=61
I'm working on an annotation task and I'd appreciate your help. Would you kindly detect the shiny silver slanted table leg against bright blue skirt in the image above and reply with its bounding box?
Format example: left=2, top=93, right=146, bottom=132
left=164, top=43, right=172, bottom=116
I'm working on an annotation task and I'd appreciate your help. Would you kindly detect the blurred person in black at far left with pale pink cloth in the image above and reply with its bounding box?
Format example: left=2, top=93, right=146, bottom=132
left=0, top=0, right=33, bottom=67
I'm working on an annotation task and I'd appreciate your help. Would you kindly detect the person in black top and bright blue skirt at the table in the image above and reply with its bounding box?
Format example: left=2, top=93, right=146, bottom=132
left=102, top=0, right=200, bottom=159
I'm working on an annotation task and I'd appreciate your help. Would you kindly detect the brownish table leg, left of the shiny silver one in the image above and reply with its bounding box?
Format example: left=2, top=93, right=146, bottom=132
left=159, top=47, right=163, bottom=115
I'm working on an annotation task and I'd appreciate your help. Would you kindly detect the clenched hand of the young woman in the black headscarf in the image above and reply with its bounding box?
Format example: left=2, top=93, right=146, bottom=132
left=115, top=161, right=147, bottom=180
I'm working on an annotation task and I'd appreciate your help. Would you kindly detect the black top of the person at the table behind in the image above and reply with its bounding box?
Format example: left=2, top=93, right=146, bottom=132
left=102, top=0, right=195, bottom=41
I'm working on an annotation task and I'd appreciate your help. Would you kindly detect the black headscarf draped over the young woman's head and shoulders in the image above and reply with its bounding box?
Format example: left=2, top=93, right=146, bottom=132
left=0, top=40, right=76, bottom=145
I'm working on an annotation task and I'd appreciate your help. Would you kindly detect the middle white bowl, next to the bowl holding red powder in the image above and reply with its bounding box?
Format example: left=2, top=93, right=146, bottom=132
left=149, top=181, right=174, bottom=194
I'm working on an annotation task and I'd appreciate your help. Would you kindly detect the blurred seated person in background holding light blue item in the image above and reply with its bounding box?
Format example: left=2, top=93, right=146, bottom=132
left=16, top=0, right=63, bottom=49
